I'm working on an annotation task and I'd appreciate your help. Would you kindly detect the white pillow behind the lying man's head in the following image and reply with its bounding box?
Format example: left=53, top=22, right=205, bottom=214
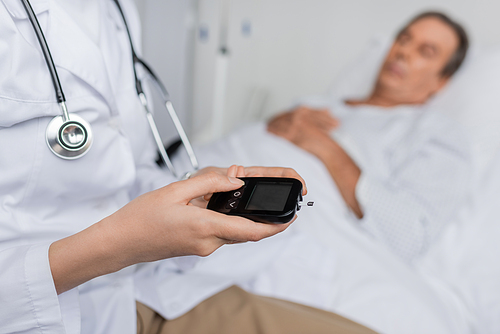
left=330, top=36, right=500, bottom=174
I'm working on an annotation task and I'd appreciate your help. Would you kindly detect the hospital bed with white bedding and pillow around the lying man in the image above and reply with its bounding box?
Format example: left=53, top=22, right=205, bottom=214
left=172, top=38, right=500, bottom=333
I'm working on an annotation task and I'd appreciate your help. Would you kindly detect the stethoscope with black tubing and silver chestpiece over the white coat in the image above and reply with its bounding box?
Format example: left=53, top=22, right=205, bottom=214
left=21, top=0, right=199, bottom=178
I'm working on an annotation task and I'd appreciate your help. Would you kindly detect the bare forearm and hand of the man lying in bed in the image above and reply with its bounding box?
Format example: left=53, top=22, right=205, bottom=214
left=268, top=107, right=363, bottom=218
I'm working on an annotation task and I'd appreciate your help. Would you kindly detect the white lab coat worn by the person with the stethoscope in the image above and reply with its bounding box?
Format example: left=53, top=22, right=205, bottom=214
left=0, top=0, right=334, bottom=334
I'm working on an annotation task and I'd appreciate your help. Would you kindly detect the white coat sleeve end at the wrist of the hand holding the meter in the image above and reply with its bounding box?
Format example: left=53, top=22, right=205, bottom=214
left=0, top=243, right=79, bottom=334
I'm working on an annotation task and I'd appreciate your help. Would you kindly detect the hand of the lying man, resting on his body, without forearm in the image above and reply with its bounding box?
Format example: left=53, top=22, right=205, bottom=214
left=267, top=107, right=339, bottom=155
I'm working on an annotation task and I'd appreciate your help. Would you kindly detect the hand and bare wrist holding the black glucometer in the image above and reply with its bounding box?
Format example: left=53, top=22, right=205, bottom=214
left=49, top=171, right=291, bottom=293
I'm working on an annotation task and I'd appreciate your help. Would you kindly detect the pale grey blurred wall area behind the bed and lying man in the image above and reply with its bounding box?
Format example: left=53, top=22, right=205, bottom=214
left=136, top=0, right=500, bottom=143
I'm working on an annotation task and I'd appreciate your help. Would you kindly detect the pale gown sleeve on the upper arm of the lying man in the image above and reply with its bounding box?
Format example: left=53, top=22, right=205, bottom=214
left=356, top=124, right=471, bottom=261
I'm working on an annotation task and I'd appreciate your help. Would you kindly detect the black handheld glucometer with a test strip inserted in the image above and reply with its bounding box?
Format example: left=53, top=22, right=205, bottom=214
left=207, top=177, right=313, bottom=224
